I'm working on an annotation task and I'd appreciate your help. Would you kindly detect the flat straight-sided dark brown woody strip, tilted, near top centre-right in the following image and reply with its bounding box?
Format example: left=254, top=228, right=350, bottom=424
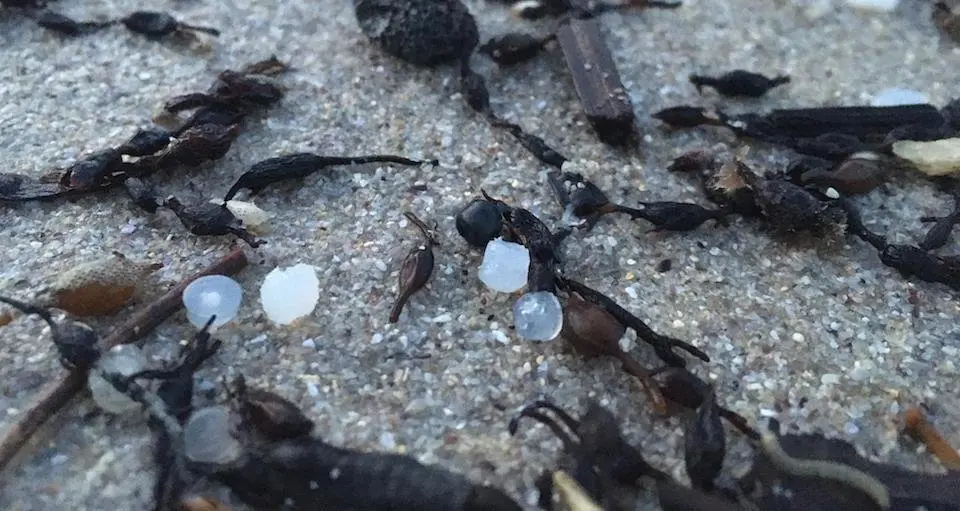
left=556, top=18, right=637, bottom=146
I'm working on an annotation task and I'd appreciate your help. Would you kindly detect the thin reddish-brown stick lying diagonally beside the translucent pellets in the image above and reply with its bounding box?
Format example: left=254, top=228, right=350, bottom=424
left=0, top=248, right=247, bottom=471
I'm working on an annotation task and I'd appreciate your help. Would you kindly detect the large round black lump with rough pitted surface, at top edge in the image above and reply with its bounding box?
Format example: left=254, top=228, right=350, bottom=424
left=353, top=0, right=480, bottom=66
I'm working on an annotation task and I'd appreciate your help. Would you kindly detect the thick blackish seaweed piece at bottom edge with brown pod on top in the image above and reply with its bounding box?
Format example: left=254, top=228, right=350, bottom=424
left=190, top=376, right=521, bottom=511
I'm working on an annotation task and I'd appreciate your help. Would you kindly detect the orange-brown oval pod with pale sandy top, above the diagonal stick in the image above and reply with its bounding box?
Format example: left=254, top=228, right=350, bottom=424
left=51, top=252, right=162, bottom=317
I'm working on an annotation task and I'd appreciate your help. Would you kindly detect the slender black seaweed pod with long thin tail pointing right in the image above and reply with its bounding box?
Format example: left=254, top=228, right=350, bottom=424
left=223, top=153, right=439, bottom=201
